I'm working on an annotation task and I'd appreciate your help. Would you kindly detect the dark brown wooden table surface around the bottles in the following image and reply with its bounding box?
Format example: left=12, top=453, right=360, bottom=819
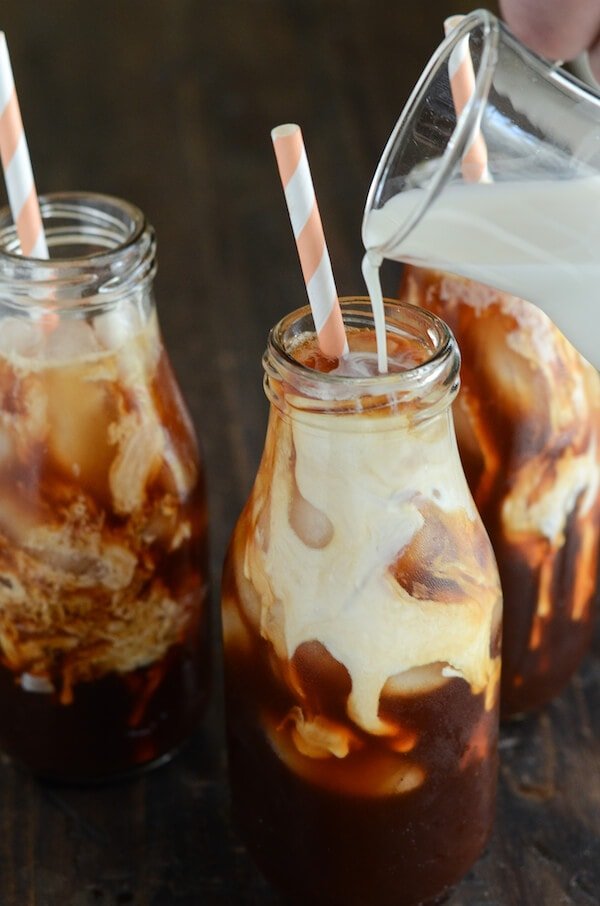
left=0, top=0, right=600, bottom=906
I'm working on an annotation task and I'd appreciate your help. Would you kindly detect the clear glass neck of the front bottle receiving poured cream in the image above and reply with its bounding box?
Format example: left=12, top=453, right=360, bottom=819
left=263, top=298, right=460, bottom=428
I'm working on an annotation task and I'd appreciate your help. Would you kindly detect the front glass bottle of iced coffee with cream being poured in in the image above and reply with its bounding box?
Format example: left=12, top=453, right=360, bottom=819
left=222, top=299, right=501, bottom=906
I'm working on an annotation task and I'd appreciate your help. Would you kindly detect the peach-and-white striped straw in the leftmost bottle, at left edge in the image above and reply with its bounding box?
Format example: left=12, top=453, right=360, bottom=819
left=0, top=32, right=48, bottom=258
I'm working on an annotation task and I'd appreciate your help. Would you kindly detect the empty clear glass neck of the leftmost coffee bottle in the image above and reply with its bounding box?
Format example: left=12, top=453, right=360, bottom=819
left=0, top=192, right=156, bottom=315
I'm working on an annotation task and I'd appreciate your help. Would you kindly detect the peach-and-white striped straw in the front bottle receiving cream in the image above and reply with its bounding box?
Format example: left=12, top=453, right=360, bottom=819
left=271, top=123, right=348, bottom=358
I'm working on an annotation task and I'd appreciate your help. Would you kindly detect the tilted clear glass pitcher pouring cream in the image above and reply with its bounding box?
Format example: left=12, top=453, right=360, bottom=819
left=363, top=10, right=600, bottom=368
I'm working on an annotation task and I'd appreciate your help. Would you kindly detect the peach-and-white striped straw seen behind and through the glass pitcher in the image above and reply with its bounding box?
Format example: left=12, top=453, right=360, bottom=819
left=444, top=16, right=491, bottom=182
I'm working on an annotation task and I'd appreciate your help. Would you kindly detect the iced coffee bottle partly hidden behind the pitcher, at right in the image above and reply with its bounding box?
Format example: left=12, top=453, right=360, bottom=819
left=401, top=266, right=600, bottom=715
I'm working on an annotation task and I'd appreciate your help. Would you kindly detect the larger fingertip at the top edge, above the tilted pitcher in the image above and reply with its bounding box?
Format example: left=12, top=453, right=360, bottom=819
left=500, top=0, right=600, bottom=60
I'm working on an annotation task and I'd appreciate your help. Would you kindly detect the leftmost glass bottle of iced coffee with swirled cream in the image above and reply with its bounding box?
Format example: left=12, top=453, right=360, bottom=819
left=0, top=193, right=207, bottom=781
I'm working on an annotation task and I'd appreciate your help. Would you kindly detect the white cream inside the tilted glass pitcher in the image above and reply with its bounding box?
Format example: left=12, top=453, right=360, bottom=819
left=362, top=176, right=600, bottom=368
